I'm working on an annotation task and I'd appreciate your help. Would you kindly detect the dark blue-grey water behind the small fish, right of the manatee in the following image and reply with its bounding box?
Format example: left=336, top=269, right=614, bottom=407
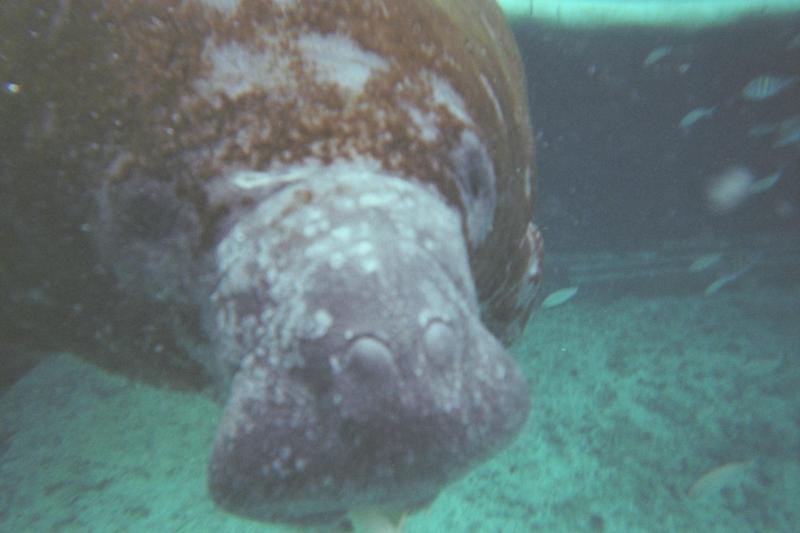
left=514, top=14, right=800, bottom=251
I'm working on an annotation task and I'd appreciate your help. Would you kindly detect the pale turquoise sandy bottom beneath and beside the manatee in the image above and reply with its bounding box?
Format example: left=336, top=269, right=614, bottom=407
left=0, top=272, right=800, bottom=533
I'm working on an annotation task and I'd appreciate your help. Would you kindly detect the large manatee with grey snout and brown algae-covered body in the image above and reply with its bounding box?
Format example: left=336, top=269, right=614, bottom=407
left=0, top=0, right=541, bottom=523
